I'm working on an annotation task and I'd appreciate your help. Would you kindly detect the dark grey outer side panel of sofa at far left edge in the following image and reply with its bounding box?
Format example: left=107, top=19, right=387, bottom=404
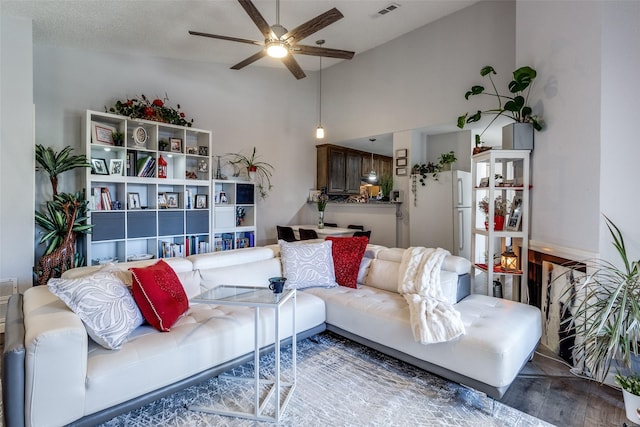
left=2, top=294, right=25, bottom=426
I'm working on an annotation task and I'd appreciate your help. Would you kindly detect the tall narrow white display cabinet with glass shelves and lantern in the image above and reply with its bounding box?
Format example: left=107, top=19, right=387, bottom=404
left=471, top=150, right=530, bottom=302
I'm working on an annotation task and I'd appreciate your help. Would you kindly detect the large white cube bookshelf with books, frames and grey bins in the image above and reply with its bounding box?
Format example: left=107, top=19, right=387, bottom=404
left=84, top=111, right=213, bottom=265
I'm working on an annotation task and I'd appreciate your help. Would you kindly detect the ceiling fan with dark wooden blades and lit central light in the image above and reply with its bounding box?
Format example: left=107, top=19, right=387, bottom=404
left=189, top=0, right=355, bottom=79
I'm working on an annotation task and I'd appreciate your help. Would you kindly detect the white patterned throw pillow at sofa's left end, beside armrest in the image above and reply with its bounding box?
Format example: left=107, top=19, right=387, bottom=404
left=47, top=270, right=144, bottom=350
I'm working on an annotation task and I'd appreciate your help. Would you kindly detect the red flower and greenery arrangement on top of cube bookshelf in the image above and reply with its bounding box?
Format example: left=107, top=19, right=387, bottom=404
left=105, top=94, right=193, bottom=127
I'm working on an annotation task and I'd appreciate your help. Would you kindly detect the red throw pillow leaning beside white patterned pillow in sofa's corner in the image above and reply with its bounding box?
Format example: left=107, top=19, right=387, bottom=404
left=325, top=236, right=369, bottom=288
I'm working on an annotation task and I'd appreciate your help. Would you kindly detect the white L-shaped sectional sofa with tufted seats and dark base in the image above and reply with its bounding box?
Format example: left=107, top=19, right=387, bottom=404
left=2, top=245, right=541, bottom=427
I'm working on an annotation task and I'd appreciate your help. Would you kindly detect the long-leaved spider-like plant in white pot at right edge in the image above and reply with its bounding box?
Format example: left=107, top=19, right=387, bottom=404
left=563, top=216, right=640, bottom=424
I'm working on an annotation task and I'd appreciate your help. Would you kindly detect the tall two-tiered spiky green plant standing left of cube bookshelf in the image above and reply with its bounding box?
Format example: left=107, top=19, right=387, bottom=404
left=34, top=144, right=93, bottom=285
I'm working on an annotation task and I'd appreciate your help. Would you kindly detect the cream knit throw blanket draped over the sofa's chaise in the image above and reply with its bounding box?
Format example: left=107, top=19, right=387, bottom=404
left=398, top=247, right=465, bottom=344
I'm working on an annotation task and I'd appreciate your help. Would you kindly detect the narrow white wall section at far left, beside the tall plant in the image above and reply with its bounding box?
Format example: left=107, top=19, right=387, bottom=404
left=0, top=16, right=35, bottom=290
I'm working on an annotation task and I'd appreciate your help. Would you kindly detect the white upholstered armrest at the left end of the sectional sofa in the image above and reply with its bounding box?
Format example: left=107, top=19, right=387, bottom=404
left=23, top=286, right=89, bottom=425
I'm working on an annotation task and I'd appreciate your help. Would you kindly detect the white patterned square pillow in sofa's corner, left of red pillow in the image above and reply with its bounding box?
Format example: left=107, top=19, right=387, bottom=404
left=278, top=240, right=338, bottom=289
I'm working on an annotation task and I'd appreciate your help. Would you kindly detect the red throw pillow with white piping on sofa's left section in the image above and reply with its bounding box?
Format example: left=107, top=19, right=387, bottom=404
left=129, top=260, right=189, bottom=332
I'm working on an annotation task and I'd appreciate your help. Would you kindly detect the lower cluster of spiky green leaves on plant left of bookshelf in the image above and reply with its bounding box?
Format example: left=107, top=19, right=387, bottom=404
left=35, top=192, right=93, bottom=255
